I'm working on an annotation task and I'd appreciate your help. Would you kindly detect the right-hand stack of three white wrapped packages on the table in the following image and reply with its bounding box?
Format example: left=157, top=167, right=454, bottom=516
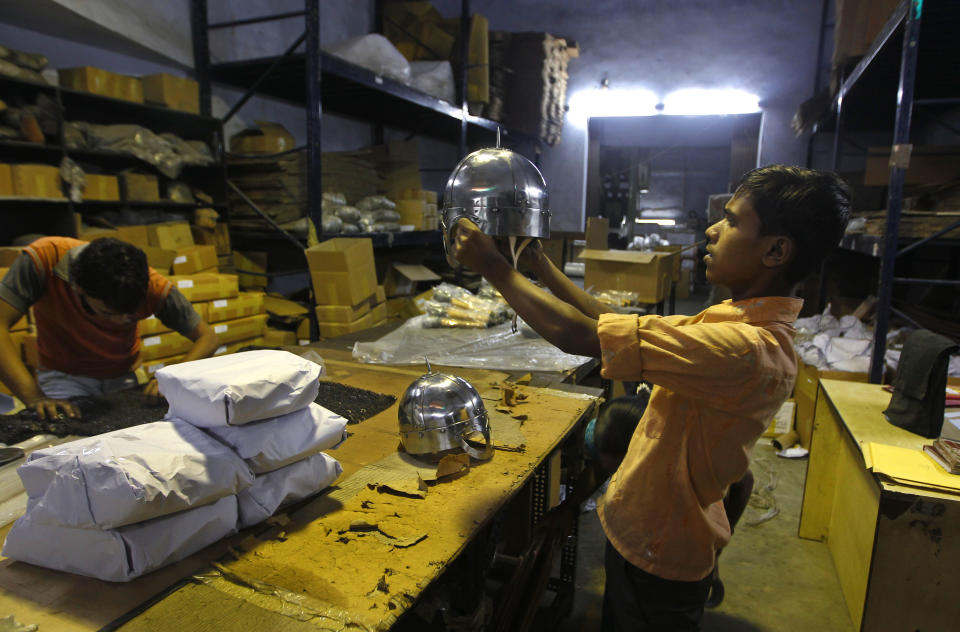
left=157, top=351, right=347, bottom=528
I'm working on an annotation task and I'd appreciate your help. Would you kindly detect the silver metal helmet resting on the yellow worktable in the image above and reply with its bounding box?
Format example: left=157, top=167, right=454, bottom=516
left=398, top=365, right=493, bottom=460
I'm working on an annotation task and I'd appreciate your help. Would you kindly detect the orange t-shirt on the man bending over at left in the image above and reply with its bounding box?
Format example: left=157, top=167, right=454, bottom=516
left=24, top=237, right=172, bottom=379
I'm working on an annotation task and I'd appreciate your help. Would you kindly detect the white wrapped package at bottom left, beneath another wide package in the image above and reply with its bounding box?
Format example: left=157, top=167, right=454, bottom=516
left=3, top=496, right=237, bottom=582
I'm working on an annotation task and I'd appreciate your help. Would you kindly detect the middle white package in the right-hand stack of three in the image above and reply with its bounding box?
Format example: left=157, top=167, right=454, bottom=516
left=206, top=404, right=347, bottom=474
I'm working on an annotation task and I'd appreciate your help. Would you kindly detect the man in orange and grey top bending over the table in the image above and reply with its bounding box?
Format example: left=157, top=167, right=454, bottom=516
left=0, top=237, right=218, bottom=419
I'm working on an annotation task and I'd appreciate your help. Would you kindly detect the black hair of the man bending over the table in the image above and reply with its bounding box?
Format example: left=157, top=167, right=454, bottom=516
left=70, top=237, right=150, bottom=314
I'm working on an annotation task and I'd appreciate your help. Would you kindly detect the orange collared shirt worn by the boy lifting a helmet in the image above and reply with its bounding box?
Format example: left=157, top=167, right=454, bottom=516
left=598, top=297, right=803, bottom=581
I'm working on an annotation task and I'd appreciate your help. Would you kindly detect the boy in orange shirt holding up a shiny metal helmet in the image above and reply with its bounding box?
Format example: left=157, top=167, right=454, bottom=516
left=453, top=165, right=850, bottom=632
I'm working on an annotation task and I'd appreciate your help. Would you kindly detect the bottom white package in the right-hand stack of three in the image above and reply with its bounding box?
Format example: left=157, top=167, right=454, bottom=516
left=237, top=452, right=343, bottom=529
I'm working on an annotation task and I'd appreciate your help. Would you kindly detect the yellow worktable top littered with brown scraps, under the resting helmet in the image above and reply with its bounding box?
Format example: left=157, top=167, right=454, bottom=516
left=0, top=358, right=597, bottom=632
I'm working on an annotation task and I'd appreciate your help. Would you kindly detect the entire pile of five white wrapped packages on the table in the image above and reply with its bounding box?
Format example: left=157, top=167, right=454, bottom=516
left=3, top=351, right=346, bottom=581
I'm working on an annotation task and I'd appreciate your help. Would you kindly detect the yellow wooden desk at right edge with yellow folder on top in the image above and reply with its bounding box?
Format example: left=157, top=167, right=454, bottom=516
left=799, top=380, right=960, bottom=632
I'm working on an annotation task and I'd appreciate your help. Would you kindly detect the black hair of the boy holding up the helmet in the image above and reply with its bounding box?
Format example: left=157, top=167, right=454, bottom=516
left=735, top=165, right=851, bottom=284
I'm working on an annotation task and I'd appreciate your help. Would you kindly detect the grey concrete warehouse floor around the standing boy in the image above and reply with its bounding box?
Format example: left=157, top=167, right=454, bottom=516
left=556, top=288, right=853, bottom=632
